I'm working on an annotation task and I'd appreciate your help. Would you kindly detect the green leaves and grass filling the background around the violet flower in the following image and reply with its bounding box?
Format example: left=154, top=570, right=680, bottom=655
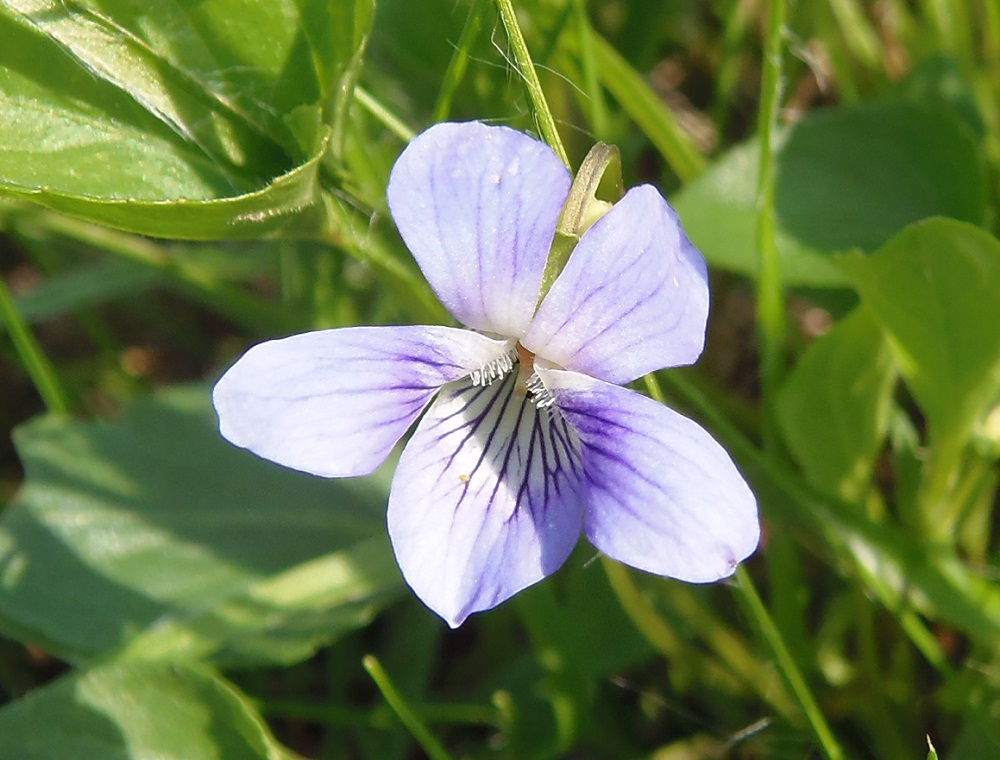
left=0, top=0, right=1000, bottom=760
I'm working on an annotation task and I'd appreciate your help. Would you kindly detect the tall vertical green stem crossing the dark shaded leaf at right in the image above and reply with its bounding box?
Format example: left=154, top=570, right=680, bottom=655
left=757, top=0, right=787, bottom=449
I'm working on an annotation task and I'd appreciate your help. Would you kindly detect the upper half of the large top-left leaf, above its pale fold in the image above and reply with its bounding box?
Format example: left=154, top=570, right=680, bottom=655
left=2, top=0, right=324, bottom=157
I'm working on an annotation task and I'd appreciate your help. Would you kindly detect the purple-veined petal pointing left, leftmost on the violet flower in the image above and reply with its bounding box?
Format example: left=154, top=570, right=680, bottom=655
left=212, top=326, right=509, bottom=477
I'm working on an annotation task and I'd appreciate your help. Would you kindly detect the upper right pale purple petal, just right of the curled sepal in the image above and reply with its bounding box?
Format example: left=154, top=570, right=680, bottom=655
left=521, top=185, right=708, bottom=383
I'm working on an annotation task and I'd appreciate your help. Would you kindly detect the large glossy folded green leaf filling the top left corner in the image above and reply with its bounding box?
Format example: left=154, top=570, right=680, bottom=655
left=0, top=0, right=370, bottom=239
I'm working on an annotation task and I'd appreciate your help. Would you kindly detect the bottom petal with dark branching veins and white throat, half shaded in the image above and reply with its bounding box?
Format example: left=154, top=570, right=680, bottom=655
left=389, top=373, right=583, bottom=627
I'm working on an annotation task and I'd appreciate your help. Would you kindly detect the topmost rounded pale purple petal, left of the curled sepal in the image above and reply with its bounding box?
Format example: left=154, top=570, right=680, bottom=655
left=386, top=122, right=570, bottom=337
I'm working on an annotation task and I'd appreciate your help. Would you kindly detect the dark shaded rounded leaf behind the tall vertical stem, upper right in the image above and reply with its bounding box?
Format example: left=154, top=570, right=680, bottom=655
left=673, top=102, right=985, bottom=287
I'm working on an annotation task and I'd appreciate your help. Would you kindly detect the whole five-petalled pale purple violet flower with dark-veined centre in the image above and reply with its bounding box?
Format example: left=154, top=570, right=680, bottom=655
left=214, top=122, right=759, bottom=626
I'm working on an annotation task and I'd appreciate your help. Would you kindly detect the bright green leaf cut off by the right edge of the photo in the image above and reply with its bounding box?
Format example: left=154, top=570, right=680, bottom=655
left=841, top=219, right=1000, bottom=440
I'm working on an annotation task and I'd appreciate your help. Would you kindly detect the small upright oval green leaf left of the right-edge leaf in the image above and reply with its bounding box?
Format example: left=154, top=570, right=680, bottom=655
left=777, top=307, right=896, bottom=501
